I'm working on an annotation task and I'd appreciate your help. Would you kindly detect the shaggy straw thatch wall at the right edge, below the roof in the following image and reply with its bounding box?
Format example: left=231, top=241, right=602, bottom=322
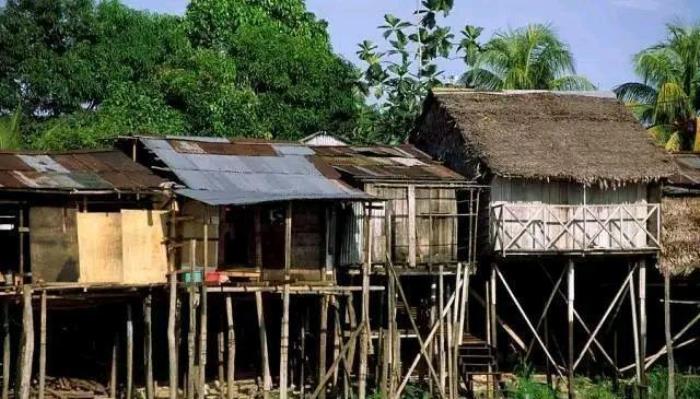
left=661, top=196, right=700, bottom=275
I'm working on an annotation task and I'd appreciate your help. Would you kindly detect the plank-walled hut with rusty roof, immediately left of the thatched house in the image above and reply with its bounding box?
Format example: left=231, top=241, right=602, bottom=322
left=314, top=144, right=479, bottom=274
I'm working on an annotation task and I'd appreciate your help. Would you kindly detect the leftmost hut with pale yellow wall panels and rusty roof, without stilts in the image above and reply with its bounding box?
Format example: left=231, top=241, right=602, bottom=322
left=0, top=151, right=167, bottom=285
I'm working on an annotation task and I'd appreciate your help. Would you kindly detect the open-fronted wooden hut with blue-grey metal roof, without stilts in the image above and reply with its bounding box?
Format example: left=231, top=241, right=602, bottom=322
left=121, top=137, right=369, bottom=282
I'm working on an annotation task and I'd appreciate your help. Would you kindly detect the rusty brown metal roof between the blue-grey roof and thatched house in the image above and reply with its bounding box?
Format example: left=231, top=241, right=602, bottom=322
left=314, top=144, right=466, bottom=181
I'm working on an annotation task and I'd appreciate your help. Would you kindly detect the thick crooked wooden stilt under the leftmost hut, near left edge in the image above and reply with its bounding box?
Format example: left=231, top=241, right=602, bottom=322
left=17, top=284, right=34, bottom=399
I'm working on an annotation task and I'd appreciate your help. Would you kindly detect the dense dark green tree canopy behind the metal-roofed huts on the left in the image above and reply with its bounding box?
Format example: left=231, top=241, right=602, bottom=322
left=0, top=0, right=358, bottom=149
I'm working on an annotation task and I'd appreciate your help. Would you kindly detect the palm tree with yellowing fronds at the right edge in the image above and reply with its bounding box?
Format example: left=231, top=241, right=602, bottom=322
left=615, top=24, right=700, bottom=151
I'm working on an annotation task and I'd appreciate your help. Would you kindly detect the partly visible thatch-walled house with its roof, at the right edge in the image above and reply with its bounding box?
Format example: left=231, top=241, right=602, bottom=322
left=661, top=153, right=700, bottom=275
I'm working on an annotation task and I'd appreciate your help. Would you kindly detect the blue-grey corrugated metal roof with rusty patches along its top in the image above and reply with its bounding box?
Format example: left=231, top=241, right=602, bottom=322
left=134, top=137, right=369, bottom=205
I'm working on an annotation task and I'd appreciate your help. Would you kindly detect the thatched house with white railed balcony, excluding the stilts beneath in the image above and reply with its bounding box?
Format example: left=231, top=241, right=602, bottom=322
left=411, top=90, right=674, bottom=255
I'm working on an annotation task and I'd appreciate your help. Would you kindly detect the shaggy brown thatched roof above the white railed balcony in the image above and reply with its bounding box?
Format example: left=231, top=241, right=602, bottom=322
left=424, top=89, right=674, bottom=186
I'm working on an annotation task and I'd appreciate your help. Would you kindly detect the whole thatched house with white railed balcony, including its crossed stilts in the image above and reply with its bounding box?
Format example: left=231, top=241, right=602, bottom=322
left=410, top=89, right=674, bottom=392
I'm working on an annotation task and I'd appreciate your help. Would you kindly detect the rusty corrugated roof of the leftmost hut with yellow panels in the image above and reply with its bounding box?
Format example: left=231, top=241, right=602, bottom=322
left=0, top=150, right=164, bottom=191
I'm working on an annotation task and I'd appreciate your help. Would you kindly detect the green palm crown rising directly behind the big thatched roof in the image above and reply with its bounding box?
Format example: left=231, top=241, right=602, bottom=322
left=462, top=24, right=595, bottom=90
